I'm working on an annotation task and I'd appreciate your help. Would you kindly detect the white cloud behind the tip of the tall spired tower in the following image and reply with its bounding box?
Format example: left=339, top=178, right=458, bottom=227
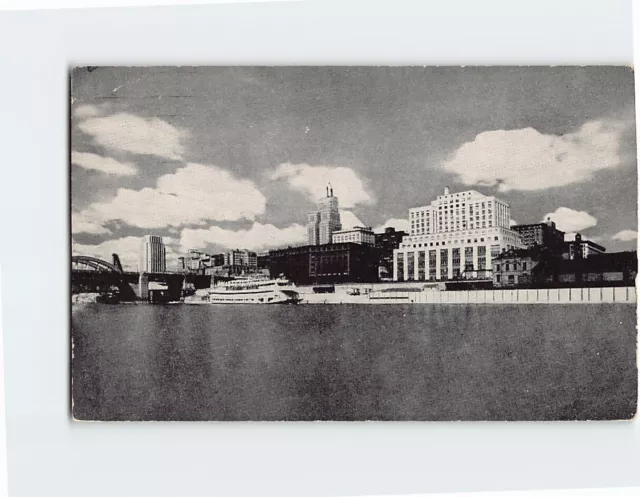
left=271, top=163, right=373, bottom=209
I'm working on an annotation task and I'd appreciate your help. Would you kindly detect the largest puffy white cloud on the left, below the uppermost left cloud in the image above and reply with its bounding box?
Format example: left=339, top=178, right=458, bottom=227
left=76, top=164, right=266, bottom=232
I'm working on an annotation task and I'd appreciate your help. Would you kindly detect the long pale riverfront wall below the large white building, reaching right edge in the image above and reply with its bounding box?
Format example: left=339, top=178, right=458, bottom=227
left=366, top=287, right=636, bottom=304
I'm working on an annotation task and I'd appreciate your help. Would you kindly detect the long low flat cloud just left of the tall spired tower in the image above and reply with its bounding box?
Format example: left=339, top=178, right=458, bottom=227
left=180, top=223, right=307, bottom=251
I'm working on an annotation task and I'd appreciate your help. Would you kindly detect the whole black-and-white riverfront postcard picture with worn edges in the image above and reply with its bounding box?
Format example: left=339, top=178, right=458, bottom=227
left=69, top=66, right=638, bottom=421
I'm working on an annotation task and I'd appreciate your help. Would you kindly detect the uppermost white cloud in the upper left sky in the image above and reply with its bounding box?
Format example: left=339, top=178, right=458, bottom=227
left=78, top=113, right=186, bottom=160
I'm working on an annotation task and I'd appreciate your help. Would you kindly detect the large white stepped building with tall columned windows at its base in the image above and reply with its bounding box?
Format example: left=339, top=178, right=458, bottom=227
left=393, top=188, right=525, bottom=281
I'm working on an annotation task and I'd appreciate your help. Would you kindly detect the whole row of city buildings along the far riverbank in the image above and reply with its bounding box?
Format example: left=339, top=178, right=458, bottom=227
left=140, top=185, right=637, bottom=288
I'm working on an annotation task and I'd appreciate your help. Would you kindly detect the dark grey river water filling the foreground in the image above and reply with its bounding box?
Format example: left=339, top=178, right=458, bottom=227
left=72, top=304, right=637, bottom=420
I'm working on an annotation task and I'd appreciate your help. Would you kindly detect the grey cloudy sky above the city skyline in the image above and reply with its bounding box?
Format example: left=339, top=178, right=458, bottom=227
left=70, top=66, right=637, bottom=270
